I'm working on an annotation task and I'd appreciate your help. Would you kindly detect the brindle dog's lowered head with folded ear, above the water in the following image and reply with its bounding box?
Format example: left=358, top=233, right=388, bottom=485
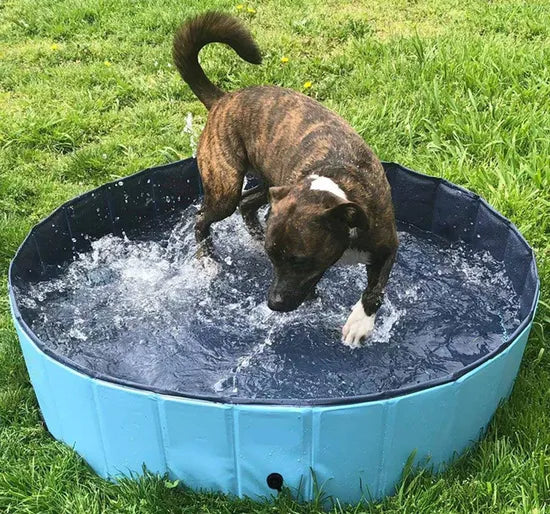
left=265, top=178, right=368, bottom=311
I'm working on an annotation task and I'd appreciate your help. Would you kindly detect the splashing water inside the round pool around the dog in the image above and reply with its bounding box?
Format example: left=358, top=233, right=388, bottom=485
left=18, top=206, right=519, bottom=399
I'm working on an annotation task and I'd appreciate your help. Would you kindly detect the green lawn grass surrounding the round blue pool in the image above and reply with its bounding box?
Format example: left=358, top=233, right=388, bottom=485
left=0, top=0, right=550, bottom=514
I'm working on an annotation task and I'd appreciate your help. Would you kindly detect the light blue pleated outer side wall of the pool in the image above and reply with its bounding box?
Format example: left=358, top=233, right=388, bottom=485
left=11, top=302, right=531, bottom=502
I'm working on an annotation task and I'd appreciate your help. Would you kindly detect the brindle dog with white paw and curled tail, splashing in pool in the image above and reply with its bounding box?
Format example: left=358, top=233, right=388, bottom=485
left=173, top=12, right=398, bottom=347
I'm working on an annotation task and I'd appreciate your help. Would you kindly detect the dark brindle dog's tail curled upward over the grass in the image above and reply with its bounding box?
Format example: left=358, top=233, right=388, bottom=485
left=176, top=11, right=262, bottom=109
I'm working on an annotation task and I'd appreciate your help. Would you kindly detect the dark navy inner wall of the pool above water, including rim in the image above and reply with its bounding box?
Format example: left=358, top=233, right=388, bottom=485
left=9, top=159, right=539, bottom=406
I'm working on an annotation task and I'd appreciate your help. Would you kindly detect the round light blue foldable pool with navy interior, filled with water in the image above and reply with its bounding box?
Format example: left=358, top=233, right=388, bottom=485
left=9, top=159, right=539, bottom=502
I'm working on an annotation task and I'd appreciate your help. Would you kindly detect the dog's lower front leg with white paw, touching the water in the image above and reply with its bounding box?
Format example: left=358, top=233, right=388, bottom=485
left=342, top=250, right=396, bottom=348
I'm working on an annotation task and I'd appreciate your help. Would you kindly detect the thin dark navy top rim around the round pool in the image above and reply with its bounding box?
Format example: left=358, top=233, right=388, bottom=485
left=8, top=157, right=540, bottom=407
